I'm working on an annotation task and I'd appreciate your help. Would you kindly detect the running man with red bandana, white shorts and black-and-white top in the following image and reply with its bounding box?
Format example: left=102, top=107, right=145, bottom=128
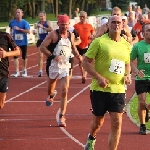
left=40, top=15, right=81, bottom=127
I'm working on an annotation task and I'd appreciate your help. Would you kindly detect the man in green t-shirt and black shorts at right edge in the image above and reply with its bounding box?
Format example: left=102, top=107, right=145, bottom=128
left=131, top=23, right=150, bottom=135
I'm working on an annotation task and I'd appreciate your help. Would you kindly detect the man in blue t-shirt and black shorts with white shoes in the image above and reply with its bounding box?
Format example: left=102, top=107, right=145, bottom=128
left=9, top=9, right=30, bottom=77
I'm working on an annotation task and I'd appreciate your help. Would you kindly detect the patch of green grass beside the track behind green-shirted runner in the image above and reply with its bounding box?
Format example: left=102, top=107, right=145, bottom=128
left=130, top=94, right=150, bottom=130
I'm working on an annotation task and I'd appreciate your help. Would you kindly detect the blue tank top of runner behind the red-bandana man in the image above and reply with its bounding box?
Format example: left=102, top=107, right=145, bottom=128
left=38, top=21, right=48, bottom=41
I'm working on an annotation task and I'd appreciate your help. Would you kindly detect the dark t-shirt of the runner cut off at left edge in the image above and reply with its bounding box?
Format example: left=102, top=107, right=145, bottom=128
left=0, top=31, right=17, bottom=77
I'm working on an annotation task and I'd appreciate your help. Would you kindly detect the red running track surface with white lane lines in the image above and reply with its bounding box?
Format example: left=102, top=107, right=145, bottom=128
left=0, top=47, right=150, bottom=150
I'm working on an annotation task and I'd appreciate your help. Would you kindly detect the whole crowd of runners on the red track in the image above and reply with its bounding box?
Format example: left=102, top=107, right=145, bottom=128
left=0, top=5, right=150, bottom=150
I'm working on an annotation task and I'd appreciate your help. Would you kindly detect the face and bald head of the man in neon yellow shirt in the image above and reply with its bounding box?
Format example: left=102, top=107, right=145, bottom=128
left=108, top=16, right=122, bottom=34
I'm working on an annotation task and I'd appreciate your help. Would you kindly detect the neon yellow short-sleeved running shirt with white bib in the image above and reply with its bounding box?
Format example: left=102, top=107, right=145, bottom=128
left=85, top=33, right=131, bottom=93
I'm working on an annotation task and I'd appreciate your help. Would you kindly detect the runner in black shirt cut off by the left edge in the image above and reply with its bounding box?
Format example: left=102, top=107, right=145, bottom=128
left=0, top=31, right=20, bottom=109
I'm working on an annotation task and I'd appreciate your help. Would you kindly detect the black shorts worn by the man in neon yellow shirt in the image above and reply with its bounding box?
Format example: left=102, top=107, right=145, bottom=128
left=90, top=91, right=125, bottom=116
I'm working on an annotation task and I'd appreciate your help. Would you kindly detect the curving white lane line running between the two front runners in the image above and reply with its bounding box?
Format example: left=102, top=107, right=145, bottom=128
left=56, top=84, right=90, bottom=147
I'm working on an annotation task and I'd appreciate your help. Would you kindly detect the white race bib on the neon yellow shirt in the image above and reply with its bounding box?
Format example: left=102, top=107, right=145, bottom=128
left=109, top=59, right=125, bottom=74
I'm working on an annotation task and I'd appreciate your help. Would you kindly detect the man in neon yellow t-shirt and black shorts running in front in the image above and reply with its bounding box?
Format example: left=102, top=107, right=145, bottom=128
left=83, top=16, right=130, bottom=150
